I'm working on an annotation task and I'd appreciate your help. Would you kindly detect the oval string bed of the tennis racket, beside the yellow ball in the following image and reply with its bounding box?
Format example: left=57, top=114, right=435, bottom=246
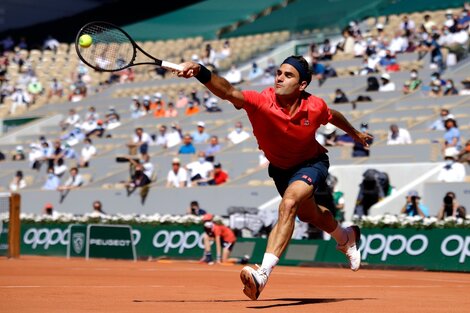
left=79, top=24, right=135, bottom=71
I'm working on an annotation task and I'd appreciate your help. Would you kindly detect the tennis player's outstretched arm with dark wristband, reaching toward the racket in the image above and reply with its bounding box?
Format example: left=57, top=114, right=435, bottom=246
left=178, top=62, right=245, bottom=109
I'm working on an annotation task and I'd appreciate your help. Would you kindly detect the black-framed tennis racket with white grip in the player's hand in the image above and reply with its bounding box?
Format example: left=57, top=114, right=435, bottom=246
left=75, top=22, right=183, bottom=72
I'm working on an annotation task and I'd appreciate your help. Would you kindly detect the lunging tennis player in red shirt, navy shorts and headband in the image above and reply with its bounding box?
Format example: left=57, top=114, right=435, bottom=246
left=178, top=56, right=372, bottom=300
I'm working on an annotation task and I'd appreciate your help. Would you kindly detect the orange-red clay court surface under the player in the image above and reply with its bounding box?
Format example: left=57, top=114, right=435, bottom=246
left=0, top=256, right=470, bottom=313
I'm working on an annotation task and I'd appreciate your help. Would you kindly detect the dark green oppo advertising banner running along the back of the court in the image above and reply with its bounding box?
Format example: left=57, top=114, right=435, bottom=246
left=21, top=224, right=470, bottom=272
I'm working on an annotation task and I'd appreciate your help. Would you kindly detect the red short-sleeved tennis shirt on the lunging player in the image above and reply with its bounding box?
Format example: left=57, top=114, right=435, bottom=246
left=243, top=87, right=331, bottom=169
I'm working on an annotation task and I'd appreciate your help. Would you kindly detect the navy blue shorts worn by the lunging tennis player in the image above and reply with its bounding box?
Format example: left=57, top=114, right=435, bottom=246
left=268, top=153, right=330, bottom=197
